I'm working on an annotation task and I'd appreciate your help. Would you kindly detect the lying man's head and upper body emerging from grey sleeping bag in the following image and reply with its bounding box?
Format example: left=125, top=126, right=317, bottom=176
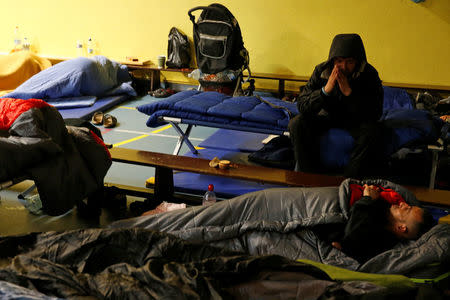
left=332, top=184, right=435, bottom=263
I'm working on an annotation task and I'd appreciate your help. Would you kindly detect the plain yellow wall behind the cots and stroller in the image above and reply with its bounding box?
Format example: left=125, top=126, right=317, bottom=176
left=0, top=0, right=450, bottom=85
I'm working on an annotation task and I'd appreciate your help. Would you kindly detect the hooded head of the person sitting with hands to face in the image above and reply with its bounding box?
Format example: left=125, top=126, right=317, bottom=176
left=328, top=33, right=366, bottom=76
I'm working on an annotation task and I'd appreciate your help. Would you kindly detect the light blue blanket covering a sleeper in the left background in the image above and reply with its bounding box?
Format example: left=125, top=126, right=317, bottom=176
left=4, top=56, right=136, bottom=106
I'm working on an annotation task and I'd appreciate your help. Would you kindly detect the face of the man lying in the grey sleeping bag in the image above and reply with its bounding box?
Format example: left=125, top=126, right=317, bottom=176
left=390, top=202, right=423, bottom=239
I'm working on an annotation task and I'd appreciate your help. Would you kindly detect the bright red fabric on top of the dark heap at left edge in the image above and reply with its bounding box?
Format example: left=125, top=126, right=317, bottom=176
left=0, top=98, right=50, bottom=130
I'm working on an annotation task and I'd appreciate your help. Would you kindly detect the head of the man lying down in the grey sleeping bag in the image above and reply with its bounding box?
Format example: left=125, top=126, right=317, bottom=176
left=388, top=202, right=434, bottom=240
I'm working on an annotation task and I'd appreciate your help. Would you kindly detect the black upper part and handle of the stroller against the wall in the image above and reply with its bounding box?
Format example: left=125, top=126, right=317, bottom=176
left=188, top=3, right=249, bottom=74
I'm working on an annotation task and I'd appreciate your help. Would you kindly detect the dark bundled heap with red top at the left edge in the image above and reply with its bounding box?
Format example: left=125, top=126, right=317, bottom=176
left=0, top=98, right=111, bottom=215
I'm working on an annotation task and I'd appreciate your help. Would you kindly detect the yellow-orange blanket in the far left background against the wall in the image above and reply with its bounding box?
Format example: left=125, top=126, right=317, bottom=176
left=0, top=51, right=52, bottom=95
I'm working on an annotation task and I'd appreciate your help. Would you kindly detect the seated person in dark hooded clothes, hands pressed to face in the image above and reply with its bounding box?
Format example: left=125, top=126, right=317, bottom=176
left=288, top=33, right=385, bottom=178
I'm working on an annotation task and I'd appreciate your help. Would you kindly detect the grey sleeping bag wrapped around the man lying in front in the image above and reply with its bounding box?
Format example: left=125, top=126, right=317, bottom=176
left=110, top=179, right=450, bottom=274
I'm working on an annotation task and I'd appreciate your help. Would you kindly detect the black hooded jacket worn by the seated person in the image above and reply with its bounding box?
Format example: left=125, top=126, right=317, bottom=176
left=297, top=34, right=383, bottom=126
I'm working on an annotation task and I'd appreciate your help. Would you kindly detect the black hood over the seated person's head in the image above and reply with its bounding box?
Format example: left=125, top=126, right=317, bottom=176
left=328, top=33, right=367, bottom=63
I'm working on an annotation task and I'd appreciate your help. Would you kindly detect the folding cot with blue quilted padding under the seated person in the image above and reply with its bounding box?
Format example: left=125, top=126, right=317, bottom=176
left=137, top=86, right=443, bottom=190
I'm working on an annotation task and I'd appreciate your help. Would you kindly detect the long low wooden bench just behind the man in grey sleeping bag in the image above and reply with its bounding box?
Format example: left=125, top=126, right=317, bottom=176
left=110, top=148, right=450, bottom=207
